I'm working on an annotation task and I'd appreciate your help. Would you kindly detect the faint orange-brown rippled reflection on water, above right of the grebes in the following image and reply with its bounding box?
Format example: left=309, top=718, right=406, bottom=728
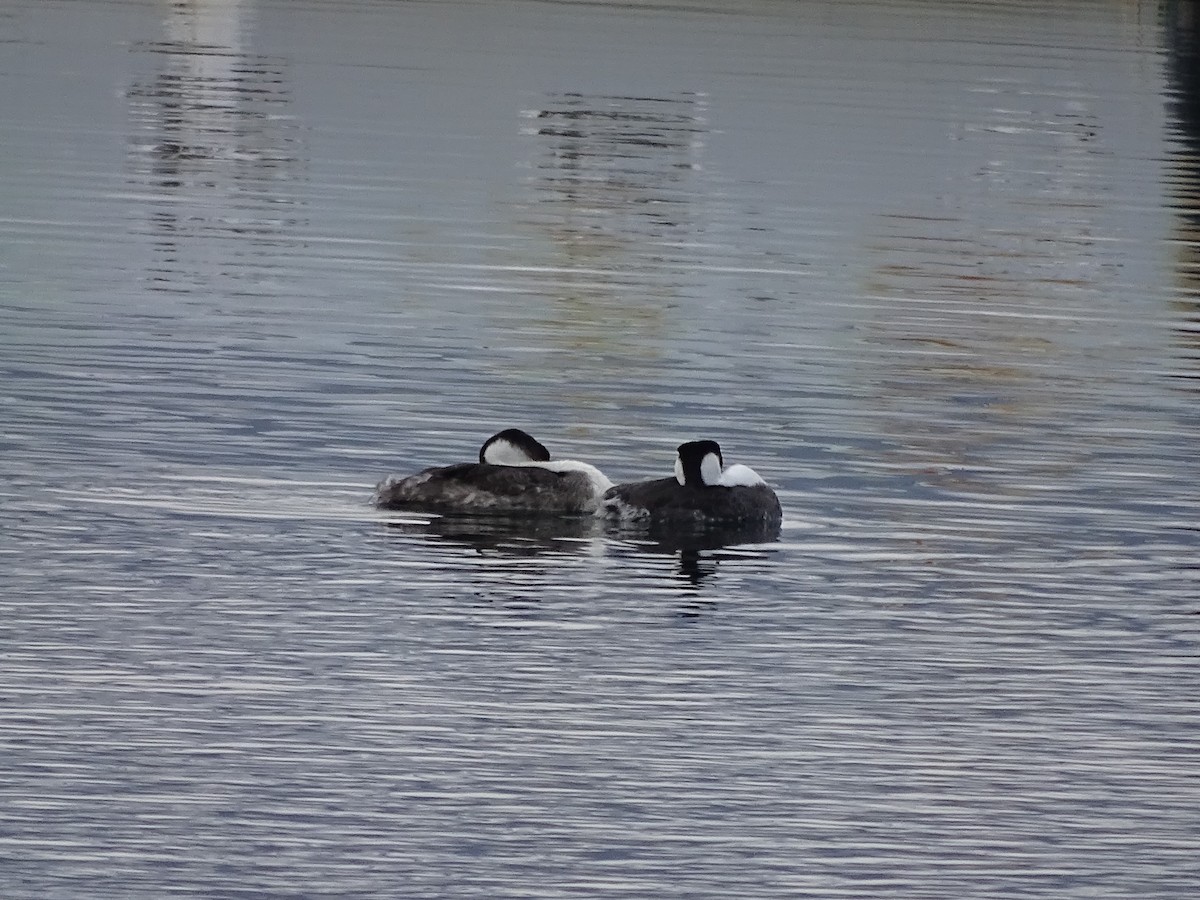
left=857, top=88, right=1112, bottom=501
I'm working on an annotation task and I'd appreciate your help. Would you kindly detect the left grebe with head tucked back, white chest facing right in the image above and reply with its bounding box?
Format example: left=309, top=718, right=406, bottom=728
left=372, top=428, right=612, bottom=515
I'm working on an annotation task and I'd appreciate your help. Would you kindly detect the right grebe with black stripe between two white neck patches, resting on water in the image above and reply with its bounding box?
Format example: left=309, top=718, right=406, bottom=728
left=602, top=440, right=784, bottom=526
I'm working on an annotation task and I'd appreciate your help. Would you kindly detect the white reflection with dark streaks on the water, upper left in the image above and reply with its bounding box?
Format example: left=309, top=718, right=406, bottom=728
left=127, top=0, right=304, bottom=293
